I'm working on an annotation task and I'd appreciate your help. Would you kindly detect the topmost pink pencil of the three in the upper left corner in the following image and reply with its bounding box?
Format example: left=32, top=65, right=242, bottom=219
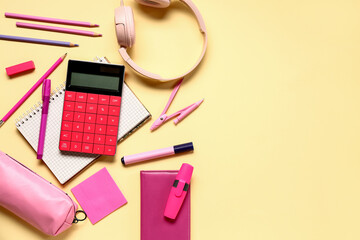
left=5, top=13, right=99, bottom=27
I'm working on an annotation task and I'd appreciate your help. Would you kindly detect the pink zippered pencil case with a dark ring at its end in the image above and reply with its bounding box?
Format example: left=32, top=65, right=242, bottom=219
left=0, top=151, right=78, bottom=236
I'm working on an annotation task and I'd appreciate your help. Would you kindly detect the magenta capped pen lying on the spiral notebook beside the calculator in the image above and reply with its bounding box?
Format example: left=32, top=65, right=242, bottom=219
left=37, top=79, right=51, bottom=159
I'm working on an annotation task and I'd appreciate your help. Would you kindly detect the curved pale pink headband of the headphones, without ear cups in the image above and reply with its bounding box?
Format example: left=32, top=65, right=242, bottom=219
left=115, top=0, right=207, bottom=82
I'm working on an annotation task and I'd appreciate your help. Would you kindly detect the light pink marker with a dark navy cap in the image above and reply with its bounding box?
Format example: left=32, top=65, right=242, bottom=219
left=121, top=142, right=194, bottom=165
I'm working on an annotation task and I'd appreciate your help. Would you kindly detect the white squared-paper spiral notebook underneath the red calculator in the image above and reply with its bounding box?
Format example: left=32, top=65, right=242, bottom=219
left=16, top=58, right=151, bottom=184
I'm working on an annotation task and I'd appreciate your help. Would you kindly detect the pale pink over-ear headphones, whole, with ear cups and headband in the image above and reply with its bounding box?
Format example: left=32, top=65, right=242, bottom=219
left=115, top=0, right=207, bottom=82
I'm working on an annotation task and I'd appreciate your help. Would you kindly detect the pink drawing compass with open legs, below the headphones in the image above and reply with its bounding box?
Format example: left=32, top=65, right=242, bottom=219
left=150, top=79, right=204, bottom=131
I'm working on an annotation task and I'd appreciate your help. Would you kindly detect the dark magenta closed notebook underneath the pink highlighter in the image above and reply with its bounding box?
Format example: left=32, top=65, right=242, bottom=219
left=140, top=171, right=190, bottom=240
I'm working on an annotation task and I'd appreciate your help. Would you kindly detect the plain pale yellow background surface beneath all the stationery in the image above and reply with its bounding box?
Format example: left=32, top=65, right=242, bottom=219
left=0, top=0, right=360, bottom=240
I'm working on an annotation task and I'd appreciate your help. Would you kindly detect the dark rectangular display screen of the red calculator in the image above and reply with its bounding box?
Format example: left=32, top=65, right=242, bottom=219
left=71, top=72, right=120, bottom=91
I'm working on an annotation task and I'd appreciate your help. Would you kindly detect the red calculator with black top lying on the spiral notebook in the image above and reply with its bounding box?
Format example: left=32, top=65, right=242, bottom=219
left=59, top=60, right=125, bottom=156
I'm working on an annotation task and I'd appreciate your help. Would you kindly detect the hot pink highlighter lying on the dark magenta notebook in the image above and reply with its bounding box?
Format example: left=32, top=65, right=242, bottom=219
left=164, top=163, right=194, bottom=219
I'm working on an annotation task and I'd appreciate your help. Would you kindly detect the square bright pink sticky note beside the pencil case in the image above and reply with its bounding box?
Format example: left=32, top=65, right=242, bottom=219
left=71, top=168, right=127, bottom=224
